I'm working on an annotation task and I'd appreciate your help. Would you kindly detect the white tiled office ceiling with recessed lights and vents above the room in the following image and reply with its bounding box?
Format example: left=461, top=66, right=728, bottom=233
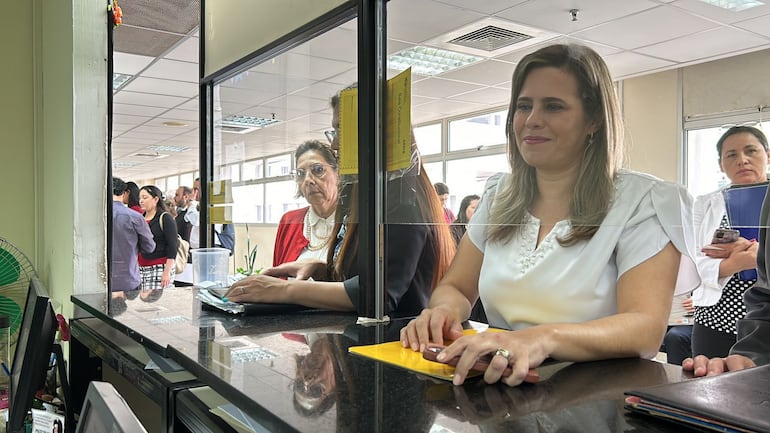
left=113, top=0, right=770, bottom=180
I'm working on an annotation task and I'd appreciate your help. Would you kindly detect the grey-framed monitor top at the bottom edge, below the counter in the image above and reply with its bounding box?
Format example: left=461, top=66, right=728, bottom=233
left=75, top=382, right=147, bottom=433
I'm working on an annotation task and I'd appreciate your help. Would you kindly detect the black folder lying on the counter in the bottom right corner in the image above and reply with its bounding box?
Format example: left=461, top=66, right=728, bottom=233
left=625, top=365, right=770, bottom=432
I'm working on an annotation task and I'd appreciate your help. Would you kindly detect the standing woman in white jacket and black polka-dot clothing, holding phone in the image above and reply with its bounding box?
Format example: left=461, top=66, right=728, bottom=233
left=692, top=126, right=770, bottom=358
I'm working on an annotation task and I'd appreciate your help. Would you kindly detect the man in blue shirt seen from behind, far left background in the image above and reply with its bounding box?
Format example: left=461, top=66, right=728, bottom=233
left=110, top=177, right=155, bottom=292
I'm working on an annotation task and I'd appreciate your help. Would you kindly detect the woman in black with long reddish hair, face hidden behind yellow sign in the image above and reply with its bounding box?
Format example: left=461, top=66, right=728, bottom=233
left=226, top=88, right=455, bottom=317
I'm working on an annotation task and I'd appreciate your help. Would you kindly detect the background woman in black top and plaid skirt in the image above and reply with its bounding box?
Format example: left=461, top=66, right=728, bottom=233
left=139, top=185, right=178, bottom=290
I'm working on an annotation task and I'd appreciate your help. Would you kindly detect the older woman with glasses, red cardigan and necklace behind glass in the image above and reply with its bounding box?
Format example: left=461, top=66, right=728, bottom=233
left=273, top=140, right=339, bottom=266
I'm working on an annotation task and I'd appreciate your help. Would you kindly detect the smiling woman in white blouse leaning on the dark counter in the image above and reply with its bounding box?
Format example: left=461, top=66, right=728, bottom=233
left=401, top=45, right=694, bottom=386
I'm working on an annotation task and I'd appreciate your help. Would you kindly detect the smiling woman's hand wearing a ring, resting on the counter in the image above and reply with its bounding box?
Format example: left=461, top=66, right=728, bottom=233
left=438, top=326, right=550, bottom=386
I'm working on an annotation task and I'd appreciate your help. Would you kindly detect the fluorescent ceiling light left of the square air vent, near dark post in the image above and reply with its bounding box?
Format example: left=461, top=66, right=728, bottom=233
left=388, top=45, right=484, bottom=75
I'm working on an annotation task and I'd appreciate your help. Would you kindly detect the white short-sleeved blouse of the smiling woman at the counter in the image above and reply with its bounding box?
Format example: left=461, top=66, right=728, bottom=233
left=468, top=170, right=697, bottom=329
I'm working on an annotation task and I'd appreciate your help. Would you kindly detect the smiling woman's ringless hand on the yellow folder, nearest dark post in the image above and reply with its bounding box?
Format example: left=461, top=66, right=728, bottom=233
left=401, top=307, right=463, bottom=352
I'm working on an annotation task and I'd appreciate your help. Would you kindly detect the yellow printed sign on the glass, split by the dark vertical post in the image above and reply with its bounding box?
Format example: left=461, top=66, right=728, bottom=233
left=339, top=69, right=412, bottom=174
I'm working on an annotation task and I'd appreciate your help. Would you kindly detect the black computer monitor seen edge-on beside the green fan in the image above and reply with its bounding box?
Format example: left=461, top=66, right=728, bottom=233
left=6, top=277, right=58, bottom=433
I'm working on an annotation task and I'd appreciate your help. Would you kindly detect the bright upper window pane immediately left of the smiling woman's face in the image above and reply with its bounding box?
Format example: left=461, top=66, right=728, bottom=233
left=449, top=109, right=508, bottom=152
